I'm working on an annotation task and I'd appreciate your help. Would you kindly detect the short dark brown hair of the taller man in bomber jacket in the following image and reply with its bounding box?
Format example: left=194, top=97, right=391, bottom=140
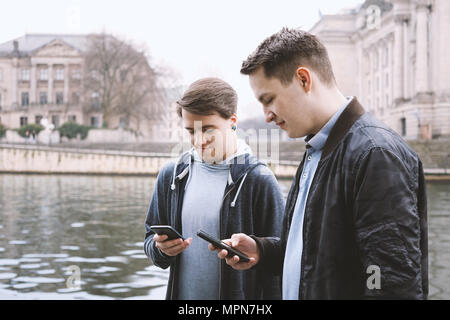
left=241, top=28, right=336, bottom=85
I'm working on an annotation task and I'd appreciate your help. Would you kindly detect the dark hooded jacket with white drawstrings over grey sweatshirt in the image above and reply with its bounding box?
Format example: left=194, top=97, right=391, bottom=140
left=144, top=154, right=285, bottom=300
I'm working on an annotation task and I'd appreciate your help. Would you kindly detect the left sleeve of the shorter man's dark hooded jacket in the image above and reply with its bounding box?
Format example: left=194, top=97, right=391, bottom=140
left=144, top=166, right=175, bottom=269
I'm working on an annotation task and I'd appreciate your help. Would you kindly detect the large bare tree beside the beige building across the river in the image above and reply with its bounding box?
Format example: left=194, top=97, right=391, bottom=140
left=83, top=33, right=166, bottom=131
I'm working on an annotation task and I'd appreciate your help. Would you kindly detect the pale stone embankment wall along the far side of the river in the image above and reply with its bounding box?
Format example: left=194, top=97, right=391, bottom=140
left=0, top=141, right=450, bottom=181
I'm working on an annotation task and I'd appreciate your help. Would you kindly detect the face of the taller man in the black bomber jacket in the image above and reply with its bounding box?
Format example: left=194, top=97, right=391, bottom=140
left=250, top=67, right=314, bottom=138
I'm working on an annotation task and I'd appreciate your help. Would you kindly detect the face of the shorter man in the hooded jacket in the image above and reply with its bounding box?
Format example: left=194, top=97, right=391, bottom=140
left=182, top=109, right=237, bottom=163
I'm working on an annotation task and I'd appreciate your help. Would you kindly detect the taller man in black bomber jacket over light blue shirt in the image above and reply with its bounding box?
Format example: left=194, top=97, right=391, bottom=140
left=210, top=28, right=428, bottom=299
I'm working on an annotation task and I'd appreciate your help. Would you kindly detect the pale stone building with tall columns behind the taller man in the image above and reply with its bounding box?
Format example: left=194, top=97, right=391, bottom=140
left=310, top=0, right=450, bottom=139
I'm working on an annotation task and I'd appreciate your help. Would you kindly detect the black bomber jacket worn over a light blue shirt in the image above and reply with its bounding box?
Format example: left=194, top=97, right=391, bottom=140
left=253, top=98, right=428, bottom=299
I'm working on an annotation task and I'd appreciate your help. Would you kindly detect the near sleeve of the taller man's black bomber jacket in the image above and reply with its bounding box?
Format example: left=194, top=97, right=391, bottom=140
left=353, top=147, right=426, bottom=299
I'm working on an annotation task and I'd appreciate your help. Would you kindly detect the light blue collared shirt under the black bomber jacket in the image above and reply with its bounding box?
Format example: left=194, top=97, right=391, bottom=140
left=283, top=97, right=353, bottom=300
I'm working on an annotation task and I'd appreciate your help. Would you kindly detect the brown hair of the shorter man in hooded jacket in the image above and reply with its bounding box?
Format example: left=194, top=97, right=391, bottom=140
left=177, top=78, right=237, bottom=119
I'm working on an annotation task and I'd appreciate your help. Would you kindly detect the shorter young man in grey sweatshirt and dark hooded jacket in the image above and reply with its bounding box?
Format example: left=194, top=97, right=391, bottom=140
left=144, top=78, right=284, bottom=300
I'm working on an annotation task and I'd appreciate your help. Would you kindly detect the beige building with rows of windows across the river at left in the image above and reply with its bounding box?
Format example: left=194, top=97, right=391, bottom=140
left=0, top=34, right=179, bottom=141
